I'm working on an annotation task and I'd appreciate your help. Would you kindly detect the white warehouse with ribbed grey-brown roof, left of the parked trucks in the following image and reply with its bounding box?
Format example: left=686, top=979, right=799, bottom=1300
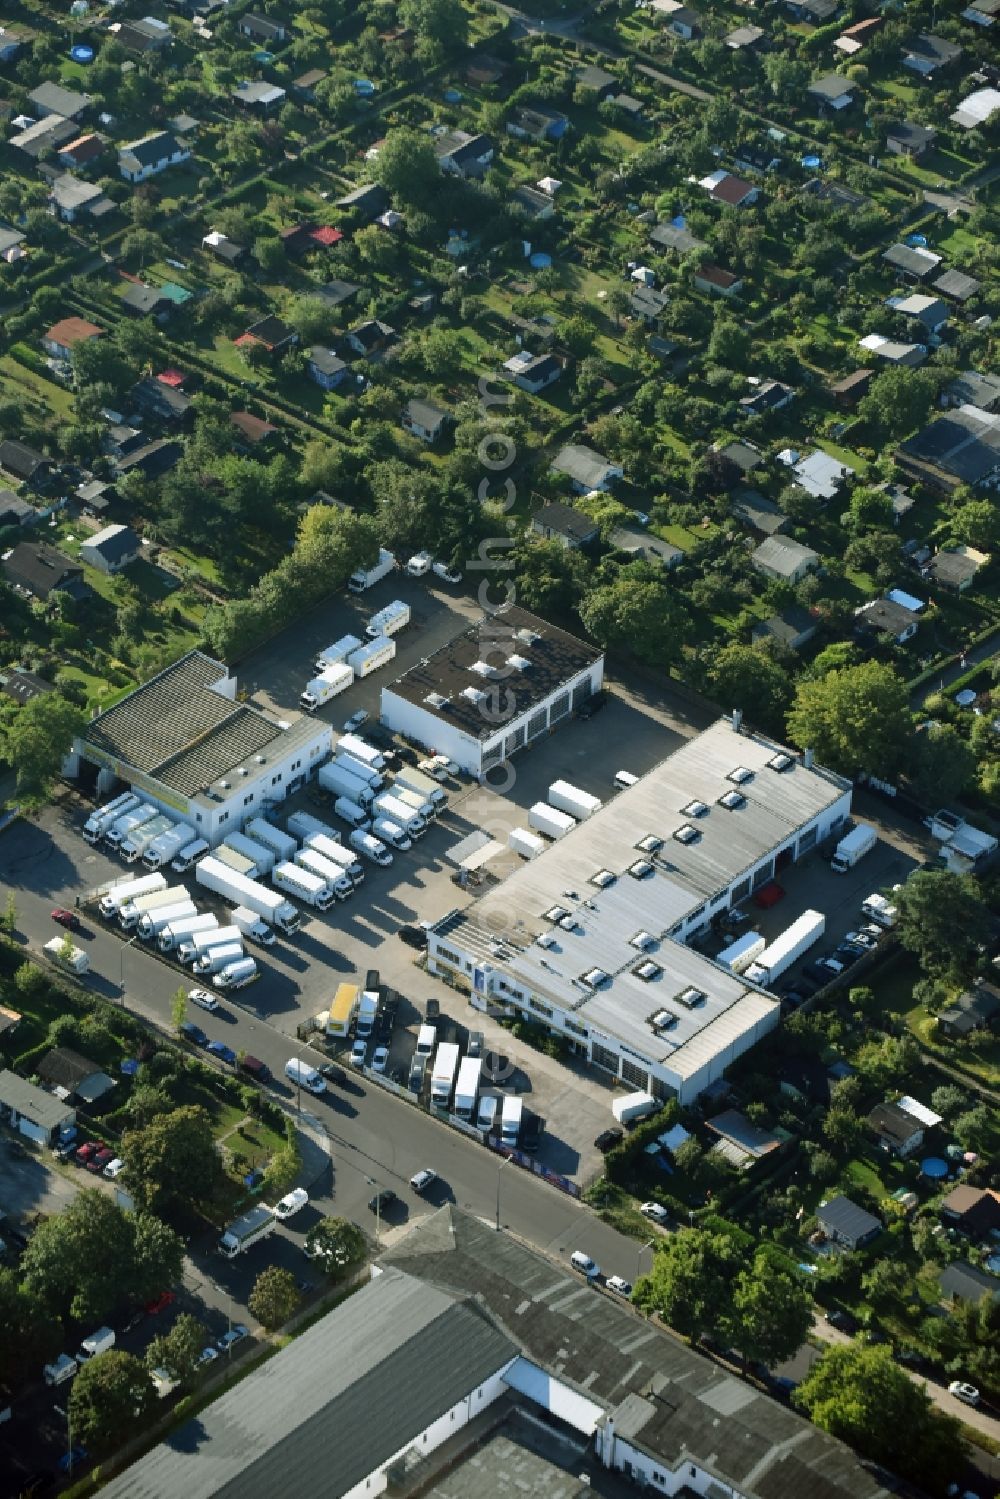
left=69, top=651, right=333, bottom=847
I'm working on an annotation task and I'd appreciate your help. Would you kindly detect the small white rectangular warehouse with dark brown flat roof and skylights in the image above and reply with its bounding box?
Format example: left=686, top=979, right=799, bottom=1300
left=381, top=606, right=604, bottom=776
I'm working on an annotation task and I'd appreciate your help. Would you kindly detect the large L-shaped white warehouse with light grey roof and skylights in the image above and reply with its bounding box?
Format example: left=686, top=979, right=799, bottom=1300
left=427, top=720, right=852, bottom=1103
